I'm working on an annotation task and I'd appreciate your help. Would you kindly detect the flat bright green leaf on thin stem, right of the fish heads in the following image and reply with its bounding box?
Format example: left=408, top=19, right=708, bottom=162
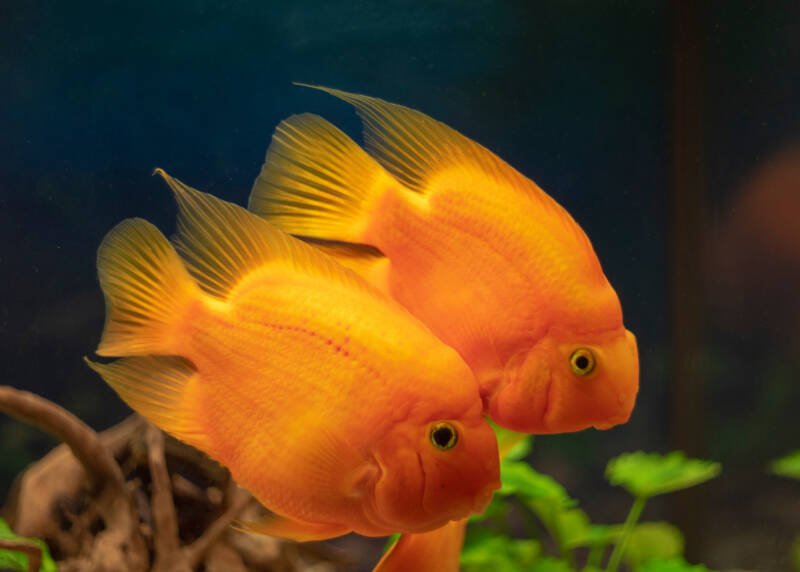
left=606, top=451, right=721, bottom=498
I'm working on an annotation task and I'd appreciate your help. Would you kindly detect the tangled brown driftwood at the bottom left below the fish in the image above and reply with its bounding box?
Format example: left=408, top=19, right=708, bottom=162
left=0, top=386, right=349, bottom=572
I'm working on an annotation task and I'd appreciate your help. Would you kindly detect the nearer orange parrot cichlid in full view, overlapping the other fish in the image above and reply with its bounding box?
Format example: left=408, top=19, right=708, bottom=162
left=87, top=171, right=499, bottom=540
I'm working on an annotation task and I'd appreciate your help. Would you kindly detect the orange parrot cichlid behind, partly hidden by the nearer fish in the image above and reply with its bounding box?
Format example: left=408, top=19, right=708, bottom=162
left=249, top=86, right=639, bottom=433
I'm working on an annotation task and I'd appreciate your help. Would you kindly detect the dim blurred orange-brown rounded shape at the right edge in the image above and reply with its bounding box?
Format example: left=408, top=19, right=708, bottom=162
left=703, top=143, right=800, bottom=352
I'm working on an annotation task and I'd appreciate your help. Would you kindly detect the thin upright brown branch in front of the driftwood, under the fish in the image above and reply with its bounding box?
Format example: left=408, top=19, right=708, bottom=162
left=145, top=424, right=180, bottom=570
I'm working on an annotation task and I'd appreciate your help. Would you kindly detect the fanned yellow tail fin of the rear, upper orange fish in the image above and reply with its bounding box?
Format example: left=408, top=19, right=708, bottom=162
left=248, top=113, right=397, bottom=242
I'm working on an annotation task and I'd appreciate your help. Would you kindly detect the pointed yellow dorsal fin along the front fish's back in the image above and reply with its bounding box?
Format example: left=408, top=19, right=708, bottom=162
left=155, top=169, right=382, bottom=299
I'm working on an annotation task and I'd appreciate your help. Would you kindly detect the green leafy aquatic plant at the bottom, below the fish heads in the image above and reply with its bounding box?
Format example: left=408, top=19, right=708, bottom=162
left=461, top=442, right=720, bottom=572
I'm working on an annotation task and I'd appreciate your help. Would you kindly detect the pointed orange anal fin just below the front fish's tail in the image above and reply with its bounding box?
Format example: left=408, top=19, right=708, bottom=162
left=84, top=356, right=208, bottom=452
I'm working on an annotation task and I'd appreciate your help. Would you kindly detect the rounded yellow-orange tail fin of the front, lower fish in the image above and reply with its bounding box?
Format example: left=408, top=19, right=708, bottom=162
left=97, top=219, right=200, bottom=356
